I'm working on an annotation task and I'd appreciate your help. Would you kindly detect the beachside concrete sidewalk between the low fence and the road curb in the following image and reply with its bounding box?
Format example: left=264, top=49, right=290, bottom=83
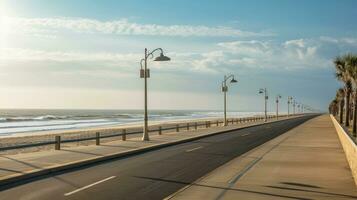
left=0, top=115, right=287, bottom=186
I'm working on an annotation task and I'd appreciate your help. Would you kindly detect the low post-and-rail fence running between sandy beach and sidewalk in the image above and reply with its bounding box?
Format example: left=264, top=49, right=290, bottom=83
left=0, top=115, right=296, bottom=151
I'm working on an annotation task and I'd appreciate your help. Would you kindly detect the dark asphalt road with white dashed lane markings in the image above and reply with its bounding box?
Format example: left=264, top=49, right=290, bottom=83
left=0, top=116, right=312, bottom=200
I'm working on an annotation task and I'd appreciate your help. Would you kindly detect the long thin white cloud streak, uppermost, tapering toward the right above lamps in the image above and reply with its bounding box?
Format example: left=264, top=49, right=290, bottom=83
left=5, top=18, right=273, bottom=37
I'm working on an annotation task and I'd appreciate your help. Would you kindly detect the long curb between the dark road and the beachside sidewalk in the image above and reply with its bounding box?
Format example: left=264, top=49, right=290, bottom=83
left=0, top=115, right=316, bottom=190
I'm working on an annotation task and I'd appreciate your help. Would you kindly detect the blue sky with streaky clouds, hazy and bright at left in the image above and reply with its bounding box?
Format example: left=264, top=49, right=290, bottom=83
left=0, top=0, right=357, bottom=111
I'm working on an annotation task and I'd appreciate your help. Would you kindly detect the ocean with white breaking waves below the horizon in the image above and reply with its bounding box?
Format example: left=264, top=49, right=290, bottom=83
left=0, top=109, right=268, bottom=136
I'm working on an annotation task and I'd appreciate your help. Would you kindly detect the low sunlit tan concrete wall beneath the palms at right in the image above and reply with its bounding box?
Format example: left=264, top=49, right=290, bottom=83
left=330, top=115, right=357, bottom=186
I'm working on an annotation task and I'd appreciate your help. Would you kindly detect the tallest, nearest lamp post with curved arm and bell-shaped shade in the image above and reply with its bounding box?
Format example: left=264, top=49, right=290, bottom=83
left=140, top=48, right=170, bottom=141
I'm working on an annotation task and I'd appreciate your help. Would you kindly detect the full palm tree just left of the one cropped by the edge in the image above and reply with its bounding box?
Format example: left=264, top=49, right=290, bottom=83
left=334, top=54, right=352, bottom=126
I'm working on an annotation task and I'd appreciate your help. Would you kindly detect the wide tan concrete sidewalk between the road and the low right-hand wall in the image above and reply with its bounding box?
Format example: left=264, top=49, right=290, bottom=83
left=166, top=115, right=357, bottom=200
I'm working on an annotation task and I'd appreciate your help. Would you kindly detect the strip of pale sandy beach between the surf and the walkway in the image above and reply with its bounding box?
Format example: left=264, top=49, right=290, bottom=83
left=0, top=115, right=234, bottom=154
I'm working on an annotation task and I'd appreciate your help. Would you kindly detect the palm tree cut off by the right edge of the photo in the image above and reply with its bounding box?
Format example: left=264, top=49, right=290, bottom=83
left=345, top=54, right=357, bottom=136
